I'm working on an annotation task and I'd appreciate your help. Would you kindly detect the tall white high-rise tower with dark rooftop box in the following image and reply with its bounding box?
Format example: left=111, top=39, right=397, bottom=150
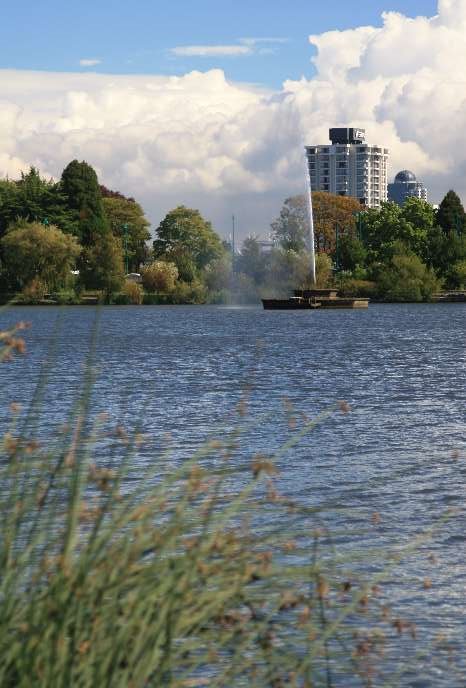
left=306, top=127, right=389, bottom=208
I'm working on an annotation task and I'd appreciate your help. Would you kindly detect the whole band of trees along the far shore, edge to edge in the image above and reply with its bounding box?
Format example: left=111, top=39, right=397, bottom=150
left=0, top=160, right=466, bottom=303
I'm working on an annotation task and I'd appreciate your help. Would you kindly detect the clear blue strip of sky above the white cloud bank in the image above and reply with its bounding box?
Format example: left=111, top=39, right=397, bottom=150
left=0, top=0, right=437, bottom=87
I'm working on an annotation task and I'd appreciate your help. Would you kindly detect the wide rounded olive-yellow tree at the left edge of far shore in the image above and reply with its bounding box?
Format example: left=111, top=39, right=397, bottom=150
left=1, top=222, right=81, bottom=290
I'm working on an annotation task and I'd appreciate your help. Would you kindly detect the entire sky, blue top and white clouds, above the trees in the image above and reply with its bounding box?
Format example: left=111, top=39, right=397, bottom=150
left=0, top=0, right=466, bottom=242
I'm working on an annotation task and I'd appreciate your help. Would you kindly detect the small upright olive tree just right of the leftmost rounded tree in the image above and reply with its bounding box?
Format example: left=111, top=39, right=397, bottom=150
left=81, top=232, right=124, bottom=294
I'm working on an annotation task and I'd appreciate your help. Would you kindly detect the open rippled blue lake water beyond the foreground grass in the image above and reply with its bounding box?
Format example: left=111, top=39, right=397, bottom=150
left=0, top=304, right=466, bottom=688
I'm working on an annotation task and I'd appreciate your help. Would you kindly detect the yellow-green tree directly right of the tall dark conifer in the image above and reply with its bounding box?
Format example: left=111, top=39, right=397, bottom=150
left=102, top=196, right=150, bottom=272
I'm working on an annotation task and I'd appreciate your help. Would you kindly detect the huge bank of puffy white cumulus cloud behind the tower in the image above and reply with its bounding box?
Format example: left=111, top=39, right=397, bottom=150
left=0, top=0, right=466, bottom=239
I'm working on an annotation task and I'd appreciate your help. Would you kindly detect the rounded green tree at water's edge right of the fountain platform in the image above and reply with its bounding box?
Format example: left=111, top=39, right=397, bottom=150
left=376, top=243, right=440, bottom=301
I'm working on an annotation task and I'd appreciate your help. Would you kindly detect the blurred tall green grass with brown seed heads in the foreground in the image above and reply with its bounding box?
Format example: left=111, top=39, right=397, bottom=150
left=0, top=320, right=458, bottom=688
